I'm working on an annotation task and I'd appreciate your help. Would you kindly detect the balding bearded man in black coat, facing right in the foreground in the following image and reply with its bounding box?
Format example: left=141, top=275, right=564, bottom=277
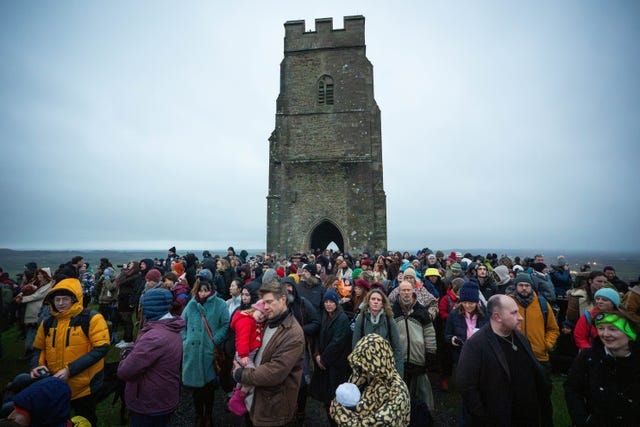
left=456, top=295, right=553, bottom=427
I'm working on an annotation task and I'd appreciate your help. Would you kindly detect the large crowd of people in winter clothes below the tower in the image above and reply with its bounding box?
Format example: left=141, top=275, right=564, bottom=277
left=0, top=247, right=640, bottom=427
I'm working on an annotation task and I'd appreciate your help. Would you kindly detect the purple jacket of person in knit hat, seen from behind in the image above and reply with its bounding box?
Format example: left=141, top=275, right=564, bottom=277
left=118, top=317, right=185, bottom=415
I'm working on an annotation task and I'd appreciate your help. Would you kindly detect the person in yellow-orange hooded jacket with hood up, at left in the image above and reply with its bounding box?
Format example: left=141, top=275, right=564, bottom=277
left=30, top=279, right=110, bottom=426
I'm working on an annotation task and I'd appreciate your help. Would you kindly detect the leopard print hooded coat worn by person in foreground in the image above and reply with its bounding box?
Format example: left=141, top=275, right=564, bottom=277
left=330, top=334, right=411, bottom=427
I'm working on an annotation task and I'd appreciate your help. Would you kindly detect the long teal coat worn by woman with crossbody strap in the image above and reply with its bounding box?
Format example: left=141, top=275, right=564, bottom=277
left=182, top=294, right=229, bottom=387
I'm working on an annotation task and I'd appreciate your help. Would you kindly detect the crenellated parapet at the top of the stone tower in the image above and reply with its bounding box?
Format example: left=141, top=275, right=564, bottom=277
left=284, top=15, right=364, bottom=53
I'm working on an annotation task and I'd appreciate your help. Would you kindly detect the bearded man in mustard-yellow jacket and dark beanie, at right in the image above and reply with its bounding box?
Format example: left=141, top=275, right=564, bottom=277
left=511, top=273, right=560, bottom=367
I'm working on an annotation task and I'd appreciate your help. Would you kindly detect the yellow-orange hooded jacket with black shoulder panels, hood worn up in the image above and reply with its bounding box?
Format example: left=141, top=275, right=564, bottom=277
left=33, top=279, right=110, bottom=400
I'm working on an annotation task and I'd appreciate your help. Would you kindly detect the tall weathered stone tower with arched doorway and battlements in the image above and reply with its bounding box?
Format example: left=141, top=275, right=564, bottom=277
left=267, top=16, right=387, bottom=255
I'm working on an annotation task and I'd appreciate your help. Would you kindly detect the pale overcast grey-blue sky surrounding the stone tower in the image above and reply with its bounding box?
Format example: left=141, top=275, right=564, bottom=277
left=0, top=0, right=640, bottom=252
